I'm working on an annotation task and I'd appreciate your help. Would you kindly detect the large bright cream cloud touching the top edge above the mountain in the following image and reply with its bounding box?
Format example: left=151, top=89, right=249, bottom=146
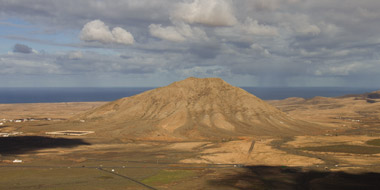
left=172, top=0, right=237, bottom=26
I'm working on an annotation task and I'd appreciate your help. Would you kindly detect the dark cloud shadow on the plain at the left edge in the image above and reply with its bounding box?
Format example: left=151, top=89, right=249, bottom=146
left=0, top=136, right=90, bottom=155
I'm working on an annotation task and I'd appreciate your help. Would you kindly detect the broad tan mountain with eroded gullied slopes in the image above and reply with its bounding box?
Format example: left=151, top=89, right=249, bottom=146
left=76, top=77, right=320, bottom=139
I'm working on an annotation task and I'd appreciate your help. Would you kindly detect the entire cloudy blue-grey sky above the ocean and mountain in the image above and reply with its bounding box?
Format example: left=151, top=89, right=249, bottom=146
left=0, top=0, right=380, bottom=88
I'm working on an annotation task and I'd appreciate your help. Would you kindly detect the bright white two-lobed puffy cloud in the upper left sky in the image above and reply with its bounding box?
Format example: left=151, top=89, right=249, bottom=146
left=80, top=20, right=134, bottom=45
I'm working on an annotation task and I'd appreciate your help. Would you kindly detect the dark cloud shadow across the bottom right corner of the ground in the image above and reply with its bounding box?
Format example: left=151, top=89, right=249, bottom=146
left=209, top=166, right=380, bottom=190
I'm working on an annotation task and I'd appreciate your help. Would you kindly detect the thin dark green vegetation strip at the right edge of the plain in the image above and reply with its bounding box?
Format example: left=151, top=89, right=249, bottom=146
left=299, top=145, right=380, bottom=154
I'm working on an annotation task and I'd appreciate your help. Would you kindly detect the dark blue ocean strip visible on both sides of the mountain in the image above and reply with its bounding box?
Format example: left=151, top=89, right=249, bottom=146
left=0, top=87, right=378, bottom=104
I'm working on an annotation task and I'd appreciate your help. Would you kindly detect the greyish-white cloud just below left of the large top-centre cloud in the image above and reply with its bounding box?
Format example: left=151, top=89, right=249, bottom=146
left=149, top=22, right=207, bottom=42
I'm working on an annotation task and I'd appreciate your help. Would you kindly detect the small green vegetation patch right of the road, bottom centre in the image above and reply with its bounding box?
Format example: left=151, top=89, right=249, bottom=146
left=141, top=170, right=195, bottom=184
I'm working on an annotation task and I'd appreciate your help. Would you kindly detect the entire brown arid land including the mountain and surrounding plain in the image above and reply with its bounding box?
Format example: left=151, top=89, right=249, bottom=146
left=0, top=78, right=380, bottom=190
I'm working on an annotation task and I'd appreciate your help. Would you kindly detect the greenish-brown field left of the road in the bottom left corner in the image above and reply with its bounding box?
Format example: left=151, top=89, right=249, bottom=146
left=0, top=168, right=134, bottom=190
